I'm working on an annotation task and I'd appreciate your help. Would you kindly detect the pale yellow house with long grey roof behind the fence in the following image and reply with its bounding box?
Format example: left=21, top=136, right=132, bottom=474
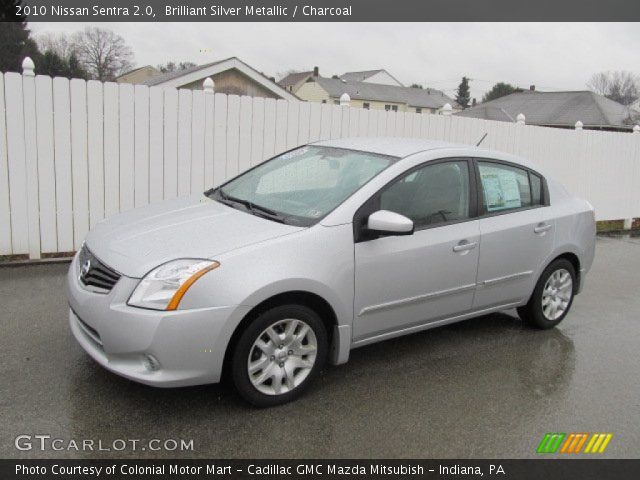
left=279, top=67, right=460, bottom=113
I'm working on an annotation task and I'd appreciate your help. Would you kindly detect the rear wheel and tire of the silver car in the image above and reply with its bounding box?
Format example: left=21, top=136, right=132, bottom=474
left=518, top=258, right=576, bottom=330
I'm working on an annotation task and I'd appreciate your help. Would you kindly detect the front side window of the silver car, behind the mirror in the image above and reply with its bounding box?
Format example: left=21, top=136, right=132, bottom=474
left=380, top=160, right=469, bottom=229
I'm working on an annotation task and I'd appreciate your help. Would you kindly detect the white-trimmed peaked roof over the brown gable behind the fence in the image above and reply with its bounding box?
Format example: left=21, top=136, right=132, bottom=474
left=143, top=57, right=298, bottom=100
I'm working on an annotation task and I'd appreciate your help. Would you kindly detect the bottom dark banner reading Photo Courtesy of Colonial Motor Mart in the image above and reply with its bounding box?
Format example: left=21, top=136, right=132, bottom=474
left=0, top=459, right=640, bottom=480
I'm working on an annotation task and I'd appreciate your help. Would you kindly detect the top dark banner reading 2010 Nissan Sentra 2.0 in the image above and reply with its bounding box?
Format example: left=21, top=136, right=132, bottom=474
left=16, top=0, right=640, bottom=22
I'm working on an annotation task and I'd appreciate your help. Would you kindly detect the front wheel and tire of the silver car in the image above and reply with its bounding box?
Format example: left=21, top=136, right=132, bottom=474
left=231, top=305, right=329, bottom=407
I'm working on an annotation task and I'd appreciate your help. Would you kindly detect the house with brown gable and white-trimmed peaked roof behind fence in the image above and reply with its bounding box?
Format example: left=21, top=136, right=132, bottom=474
left=122, top=57, right=298, bottom=101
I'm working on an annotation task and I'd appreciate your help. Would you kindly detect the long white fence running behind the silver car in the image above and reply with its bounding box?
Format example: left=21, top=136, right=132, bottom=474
left=0, top=73, right=640, bottom=258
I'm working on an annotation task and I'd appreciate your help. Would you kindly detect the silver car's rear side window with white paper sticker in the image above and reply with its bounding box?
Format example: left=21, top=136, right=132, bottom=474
left=478, top=162, right=541, bottom=213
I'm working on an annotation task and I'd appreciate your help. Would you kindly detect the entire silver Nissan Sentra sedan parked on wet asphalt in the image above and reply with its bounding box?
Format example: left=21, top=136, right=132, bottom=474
left=68, top=138, right=595, bottom=406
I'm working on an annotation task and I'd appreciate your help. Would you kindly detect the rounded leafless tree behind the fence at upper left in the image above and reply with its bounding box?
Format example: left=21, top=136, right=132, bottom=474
left=72, top=27, right=133, bottom=82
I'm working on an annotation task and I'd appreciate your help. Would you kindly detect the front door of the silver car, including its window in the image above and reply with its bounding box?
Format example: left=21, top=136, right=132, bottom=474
left=353, top=160, right=480, bottom=342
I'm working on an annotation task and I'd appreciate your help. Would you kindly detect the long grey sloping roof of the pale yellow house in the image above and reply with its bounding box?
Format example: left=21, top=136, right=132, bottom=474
left=313, top=77, right=456, bottom=109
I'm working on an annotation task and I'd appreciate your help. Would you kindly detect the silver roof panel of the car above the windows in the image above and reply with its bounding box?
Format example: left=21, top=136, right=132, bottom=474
left=312, top=137, right=542, bottom=173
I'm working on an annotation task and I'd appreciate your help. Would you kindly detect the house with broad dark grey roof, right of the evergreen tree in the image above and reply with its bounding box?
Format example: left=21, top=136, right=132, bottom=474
left=457, top=87, right=633, bottom=131
